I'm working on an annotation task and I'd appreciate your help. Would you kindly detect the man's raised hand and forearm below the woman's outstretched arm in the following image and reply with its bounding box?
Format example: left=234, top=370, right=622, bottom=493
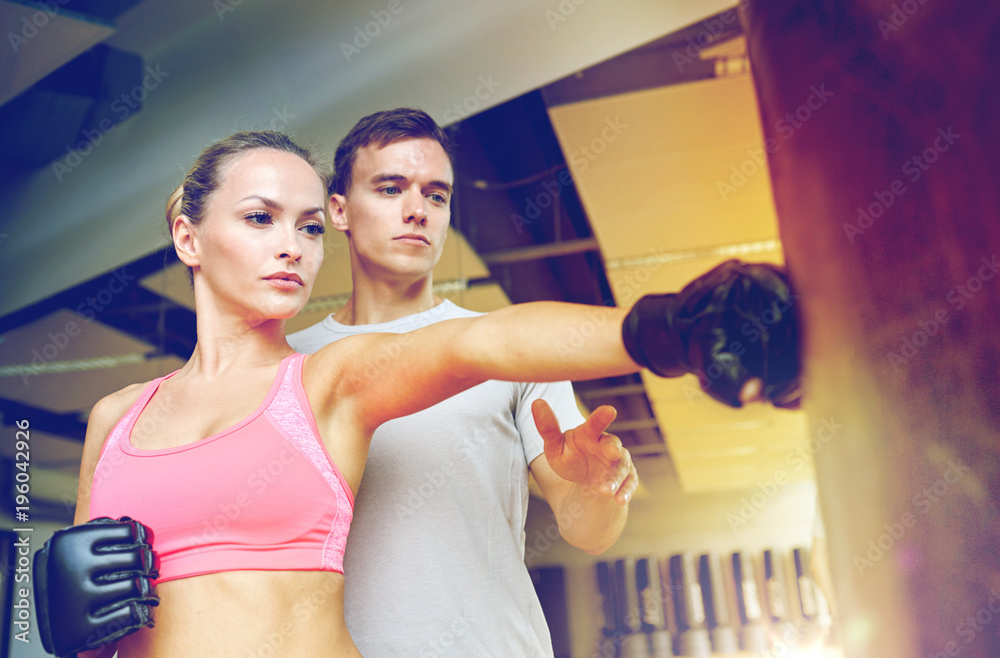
left=529, top=399, right=639, bottom=555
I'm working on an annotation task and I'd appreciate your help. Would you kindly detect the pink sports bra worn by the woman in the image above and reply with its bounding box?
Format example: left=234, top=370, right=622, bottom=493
left=90, top=354, right=354, bottom=583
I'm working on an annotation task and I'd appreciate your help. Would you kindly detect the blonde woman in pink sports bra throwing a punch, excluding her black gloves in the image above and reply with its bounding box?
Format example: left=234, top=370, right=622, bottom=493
left=46, top=132, right=796, bottom=658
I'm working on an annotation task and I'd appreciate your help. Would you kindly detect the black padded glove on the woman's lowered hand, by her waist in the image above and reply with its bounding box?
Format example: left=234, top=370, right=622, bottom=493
left=34, top=516, right=160, bottom=658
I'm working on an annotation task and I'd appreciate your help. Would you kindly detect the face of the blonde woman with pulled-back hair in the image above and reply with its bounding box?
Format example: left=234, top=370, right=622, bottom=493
left=186, top=149, right=326, bottom=324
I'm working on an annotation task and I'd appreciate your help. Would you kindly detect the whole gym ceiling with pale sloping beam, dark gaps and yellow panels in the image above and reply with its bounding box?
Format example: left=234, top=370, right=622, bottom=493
left=0, top=0, right=811, bottom=518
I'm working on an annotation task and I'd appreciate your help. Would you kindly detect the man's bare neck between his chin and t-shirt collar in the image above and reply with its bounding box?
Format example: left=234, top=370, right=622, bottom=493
left=333, top=275, right=442, bottom=326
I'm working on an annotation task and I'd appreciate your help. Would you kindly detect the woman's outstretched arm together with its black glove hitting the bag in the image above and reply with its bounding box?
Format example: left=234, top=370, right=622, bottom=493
left=314, top=260, right=801, bottom=430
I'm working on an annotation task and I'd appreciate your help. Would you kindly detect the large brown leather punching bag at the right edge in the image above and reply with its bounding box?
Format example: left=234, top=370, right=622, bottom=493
left=743, top=0, right=1000, bottom=658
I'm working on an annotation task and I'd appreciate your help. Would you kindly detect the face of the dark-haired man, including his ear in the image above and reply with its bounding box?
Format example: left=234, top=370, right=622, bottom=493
left=330, top=139, right=454, bottom=281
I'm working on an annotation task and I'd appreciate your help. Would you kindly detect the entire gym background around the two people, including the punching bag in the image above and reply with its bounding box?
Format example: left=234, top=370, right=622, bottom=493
left=0, top=0, right=1000, bottom=658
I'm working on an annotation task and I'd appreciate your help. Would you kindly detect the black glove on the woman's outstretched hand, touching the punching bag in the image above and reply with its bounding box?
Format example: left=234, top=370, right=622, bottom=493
left=622, top=260, right=802, bottom=408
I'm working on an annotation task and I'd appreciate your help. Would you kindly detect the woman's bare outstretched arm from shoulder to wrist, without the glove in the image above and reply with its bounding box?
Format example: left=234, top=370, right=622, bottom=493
left=314, top=302, right=639, bottom=430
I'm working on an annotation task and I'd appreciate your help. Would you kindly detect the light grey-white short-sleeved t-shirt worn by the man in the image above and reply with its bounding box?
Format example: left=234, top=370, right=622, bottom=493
left=288, top=300, right=583, bottom=658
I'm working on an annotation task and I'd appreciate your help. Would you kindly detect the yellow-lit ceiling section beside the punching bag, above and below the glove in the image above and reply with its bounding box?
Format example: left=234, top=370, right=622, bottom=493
left=549, top=35, right=812, bottom=492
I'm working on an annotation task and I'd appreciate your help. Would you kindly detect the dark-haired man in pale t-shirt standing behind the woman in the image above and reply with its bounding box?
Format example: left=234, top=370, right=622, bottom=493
left=289, top=109, right=638, bottom=657
